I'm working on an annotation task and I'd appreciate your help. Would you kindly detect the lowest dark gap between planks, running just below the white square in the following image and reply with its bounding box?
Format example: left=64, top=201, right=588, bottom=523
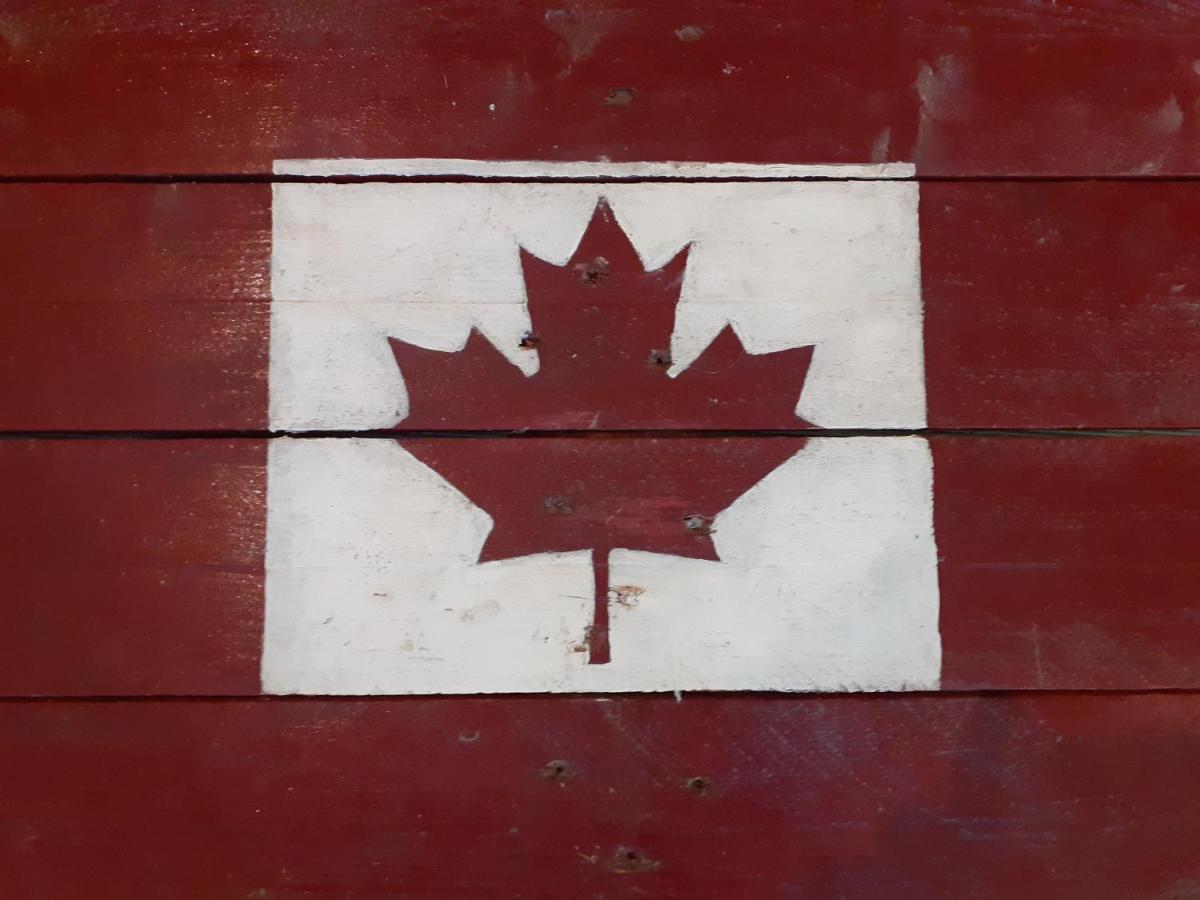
left=0, top=688, right=1200, bottom=703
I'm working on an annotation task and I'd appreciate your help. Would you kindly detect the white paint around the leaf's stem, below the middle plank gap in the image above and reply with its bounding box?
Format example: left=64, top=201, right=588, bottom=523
left=263, top=437, right=941, bottom=694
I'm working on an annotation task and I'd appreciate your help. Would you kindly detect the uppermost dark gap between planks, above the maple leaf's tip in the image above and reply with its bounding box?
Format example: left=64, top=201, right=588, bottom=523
left=9, top=173, right=1200, bottom=185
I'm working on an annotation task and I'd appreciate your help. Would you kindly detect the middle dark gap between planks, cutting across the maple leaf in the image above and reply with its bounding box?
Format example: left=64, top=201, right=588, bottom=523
left=0, top=428, right=1200, bottom=440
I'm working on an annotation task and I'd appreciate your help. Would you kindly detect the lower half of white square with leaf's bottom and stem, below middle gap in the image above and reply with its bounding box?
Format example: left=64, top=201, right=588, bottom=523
left=263, top=434, right=941, bottom=695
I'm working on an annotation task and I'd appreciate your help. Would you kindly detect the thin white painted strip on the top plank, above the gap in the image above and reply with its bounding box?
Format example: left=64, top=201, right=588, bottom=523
left=275, top=158, right=917, bottom=181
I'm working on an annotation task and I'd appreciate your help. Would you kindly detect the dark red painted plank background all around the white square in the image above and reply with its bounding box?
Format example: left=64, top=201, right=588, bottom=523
left=0, top=0, right=1200, bottom=900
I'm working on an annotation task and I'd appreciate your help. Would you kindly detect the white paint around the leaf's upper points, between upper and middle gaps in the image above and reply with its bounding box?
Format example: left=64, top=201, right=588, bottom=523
left=270, top=175, right=925, bottom=430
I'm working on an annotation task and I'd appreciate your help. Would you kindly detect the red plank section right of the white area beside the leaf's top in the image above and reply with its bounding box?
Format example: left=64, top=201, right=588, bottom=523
left=920, top=182, right=1200, bottom=428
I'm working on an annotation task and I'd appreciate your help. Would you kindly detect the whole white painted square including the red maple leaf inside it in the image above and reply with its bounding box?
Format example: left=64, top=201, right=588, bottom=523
left=262, top=160, right=941, bottom=695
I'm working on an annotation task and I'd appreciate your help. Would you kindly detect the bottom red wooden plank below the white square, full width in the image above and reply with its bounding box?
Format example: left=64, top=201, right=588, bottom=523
left=0, top=694, right=1200, bottom=900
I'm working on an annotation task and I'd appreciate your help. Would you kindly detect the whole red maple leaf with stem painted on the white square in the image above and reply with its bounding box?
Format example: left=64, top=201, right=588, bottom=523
left=391, top=206, right=812, bottom=662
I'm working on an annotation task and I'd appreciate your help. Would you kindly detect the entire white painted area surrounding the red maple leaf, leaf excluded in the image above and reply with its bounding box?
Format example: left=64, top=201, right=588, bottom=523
left=263, top=160, right=941, bottom=694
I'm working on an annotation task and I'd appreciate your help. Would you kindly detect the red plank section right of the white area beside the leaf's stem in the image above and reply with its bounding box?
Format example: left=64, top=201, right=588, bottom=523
left=932, top=437, right=1200, bottom=689
